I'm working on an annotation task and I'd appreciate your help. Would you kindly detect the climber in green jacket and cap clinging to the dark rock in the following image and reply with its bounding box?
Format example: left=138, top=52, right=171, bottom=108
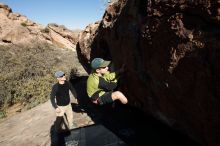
left=87, top=58, right=128, bottom=105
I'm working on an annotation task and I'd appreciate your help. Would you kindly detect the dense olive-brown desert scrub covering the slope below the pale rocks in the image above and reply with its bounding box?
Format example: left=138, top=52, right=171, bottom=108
left=0, top=43, right=79, bottom=118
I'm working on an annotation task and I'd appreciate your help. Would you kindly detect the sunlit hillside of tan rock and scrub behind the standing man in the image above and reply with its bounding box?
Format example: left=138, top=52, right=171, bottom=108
left=0, top=3, right=85, bottom=118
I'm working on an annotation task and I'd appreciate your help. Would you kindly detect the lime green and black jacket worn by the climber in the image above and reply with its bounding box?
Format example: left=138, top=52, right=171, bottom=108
left=87, top=72, right=118, bottom=100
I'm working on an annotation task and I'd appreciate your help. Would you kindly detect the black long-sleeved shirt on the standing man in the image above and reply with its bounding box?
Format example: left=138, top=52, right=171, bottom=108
left=50, top=81, right=76, bottom=108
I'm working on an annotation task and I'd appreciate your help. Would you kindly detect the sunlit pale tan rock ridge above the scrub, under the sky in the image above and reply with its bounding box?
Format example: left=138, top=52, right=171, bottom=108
left=0, top=3, right=78, bottom=50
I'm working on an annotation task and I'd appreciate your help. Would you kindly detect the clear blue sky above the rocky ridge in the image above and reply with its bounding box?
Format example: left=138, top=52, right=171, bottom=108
left=0, top=0, right=105, bottom=29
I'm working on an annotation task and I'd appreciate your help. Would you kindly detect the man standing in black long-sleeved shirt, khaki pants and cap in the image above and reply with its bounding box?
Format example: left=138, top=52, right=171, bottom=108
left=50, top=71, right=76, bottom=129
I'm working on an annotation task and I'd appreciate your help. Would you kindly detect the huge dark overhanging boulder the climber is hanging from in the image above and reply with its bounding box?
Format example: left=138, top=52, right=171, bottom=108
left=77, top=0, right=220, bottom=146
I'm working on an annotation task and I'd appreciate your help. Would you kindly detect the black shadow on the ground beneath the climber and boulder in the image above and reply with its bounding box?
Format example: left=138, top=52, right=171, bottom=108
left=51, top=77, right=200, bottom=146
